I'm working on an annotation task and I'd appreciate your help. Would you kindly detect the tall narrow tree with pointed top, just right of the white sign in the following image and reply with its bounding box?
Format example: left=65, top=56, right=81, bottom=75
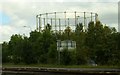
left=75, top=23, right=88, bottom=65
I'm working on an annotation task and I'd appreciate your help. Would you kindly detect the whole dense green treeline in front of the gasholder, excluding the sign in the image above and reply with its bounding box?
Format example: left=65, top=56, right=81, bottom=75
left=2, top=21, right=120, bottom=65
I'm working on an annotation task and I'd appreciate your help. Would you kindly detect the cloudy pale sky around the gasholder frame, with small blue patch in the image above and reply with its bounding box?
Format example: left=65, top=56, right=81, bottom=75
left=0, top=0, right=119, bottom=43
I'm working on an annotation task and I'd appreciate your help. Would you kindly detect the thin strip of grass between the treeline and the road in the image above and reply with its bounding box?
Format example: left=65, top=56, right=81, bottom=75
left=2, top=63, right=120, bottom=69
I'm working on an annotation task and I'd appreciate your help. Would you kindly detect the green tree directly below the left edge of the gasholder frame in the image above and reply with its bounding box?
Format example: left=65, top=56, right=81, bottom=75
left=28, top=31, right=43, bottom=63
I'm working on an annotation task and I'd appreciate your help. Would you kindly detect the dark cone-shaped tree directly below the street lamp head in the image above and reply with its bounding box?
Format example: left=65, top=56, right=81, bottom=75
left=22, top=37, right=37, bottom=64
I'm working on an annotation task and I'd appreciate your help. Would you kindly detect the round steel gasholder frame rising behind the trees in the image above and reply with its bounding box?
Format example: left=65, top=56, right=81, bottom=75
left=36, top=11, right=98, bottom=31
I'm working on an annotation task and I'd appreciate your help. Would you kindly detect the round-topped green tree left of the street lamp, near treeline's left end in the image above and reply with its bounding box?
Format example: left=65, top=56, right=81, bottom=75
left=9, top=34, right=23, bottom=64
